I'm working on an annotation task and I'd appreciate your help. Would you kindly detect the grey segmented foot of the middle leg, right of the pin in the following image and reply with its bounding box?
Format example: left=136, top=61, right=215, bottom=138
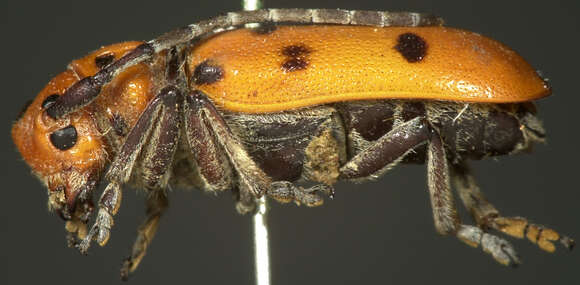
left=266, top=181, right=334, bottom=207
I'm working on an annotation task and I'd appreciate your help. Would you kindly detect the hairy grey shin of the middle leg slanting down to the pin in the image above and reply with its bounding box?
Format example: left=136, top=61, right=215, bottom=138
left=186, top=90, right=271, bottom=213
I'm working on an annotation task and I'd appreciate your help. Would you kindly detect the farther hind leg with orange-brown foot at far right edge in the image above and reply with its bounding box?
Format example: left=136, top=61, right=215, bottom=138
left=453, top=163, right=575, bottom=252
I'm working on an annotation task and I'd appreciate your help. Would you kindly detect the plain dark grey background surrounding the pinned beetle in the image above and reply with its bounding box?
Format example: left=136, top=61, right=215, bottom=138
left=0, top=0, right=580, bottom=284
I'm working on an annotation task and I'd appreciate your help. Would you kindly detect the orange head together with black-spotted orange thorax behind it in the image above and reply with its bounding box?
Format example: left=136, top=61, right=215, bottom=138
left=12, top=42, right=151, bottom=220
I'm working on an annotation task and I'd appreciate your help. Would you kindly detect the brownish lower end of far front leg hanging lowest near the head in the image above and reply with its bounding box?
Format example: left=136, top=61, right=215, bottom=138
left=121, top=189, right=168, bottom=280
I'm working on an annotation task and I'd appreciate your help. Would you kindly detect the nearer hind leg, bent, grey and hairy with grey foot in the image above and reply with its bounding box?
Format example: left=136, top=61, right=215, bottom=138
left=341, top=117, right=519, bottom=265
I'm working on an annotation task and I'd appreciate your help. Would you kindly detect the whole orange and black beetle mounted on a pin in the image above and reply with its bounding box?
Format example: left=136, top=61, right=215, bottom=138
left=12, top=9, right=574, bottom=278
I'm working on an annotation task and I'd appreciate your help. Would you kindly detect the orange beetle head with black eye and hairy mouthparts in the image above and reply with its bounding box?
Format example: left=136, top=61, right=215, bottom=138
left=12, top=71, right=107, bottom=220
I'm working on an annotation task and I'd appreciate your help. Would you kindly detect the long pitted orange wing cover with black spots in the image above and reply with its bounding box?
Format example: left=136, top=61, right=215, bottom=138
left=187, top=26, right=550, bottom=113
